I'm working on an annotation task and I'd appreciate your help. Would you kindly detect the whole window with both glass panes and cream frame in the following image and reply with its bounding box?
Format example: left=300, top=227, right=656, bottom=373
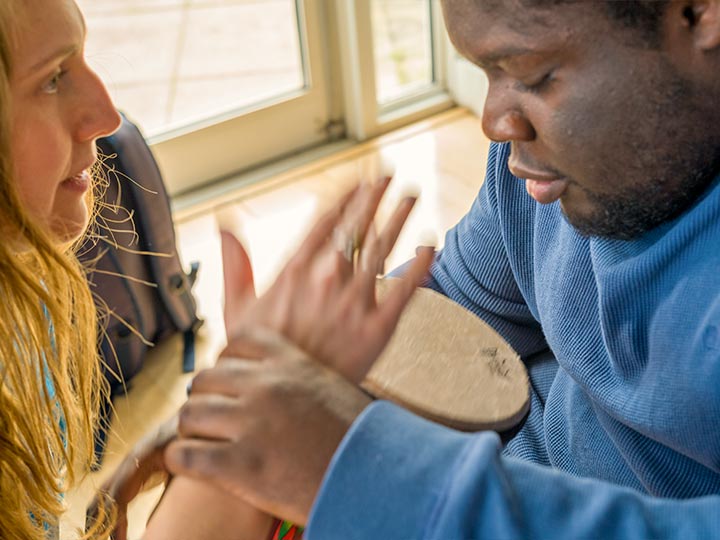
left=78, top=0, right=451, bottom=194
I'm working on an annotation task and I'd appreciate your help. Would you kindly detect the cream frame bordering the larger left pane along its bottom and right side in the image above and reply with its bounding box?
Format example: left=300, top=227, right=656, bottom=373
left=149, top=0, right=330, bottom=194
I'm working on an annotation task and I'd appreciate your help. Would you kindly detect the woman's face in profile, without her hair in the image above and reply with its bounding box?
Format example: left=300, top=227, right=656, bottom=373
left=9, top=0, right=120, bottom=241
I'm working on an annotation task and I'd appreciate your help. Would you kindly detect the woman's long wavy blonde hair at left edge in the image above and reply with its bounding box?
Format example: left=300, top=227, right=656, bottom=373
left=0, top=0, right=111, bottom=540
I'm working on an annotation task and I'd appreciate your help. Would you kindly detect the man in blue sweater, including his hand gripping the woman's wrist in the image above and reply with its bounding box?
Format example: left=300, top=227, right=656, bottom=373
left=166, top=0, right=720, bottom=539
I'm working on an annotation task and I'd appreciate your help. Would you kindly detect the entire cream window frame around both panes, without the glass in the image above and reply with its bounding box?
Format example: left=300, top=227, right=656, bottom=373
left=150, top=0, right=462, bottom=198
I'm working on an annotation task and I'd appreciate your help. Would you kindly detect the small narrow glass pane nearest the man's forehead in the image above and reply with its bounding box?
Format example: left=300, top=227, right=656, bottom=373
left=372, top=0, right=433, bottom=104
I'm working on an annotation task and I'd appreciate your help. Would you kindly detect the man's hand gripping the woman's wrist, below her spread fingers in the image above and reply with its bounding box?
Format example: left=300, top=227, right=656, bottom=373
left=165, top=329, right=370, bottom=524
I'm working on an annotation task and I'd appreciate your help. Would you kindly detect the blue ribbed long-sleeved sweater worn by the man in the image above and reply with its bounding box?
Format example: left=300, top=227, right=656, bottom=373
left=308, top=145, right=720, bottom=540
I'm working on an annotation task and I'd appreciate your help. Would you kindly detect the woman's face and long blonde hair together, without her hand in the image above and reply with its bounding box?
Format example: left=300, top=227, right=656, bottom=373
left=0, top=0, right=120, bottom=540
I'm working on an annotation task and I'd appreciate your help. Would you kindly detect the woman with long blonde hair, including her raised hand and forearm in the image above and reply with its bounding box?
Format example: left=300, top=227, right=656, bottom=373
left=0, top=0, right=430, bottom=540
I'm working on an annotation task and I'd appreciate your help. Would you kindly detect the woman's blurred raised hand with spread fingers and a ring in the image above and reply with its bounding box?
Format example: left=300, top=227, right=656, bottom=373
left=221, top=178, right=433, bottom=382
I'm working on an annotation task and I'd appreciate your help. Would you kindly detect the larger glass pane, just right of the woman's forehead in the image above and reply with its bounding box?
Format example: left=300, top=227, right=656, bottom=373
left=78, top=0, right=305, bottom=134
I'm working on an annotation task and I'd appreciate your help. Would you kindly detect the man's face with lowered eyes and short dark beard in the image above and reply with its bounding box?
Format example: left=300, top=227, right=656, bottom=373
left=443, top=0, right=720, bottom=239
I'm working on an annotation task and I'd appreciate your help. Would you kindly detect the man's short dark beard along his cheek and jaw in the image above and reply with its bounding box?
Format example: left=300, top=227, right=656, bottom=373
left=563, top=55, right=720, bottom=240
